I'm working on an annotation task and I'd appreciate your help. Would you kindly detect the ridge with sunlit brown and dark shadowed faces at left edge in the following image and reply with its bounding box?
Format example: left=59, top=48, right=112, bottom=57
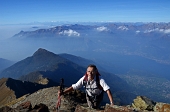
left=0, top=78, right=55, bottom=106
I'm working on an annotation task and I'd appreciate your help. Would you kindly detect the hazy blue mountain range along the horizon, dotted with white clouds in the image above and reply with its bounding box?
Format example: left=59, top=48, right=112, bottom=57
left=14, top=23, right=170, bottom=38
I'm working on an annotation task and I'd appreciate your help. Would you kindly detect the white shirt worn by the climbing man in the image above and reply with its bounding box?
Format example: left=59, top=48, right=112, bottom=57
left=72, top=76, right=110, bottom=96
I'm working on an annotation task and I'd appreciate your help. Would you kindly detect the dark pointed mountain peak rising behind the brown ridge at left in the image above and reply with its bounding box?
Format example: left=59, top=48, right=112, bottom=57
left=0, top=48, right=85, bottom=78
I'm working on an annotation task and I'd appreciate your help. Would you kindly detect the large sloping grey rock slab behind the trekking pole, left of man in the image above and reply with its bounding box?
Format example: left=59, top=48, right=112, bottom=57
left=3, top=87, right=87, bottom=112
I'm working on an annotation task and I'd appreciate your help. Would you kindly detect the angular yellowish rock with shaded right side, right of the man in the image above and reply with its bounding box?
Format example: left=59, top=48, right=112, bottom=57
left=132, top=96, right=156, bottom=111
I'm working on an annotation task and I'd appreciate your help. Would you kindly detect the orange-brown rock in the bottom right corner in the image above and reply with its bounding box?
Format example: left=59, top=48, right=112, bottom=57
left=154, top=103, right=170, bottom=112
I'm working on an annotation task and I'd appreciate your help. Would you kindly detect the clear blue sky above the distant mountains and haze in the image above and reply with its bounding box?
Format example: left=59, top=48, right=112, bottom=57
left=0, top=0, right=170, bottom=24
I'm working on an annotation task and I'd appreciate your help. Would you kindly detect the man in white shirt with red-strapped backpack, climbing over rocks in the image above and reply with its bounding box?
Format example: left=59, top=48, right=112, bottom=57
left=58, top=65, right=113, bottom=109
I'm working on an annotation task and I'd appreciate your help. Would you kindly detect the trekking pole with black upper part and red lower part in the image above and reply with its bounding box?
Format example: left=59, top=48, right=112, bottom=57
left=56, top=78, right=64, bottom=112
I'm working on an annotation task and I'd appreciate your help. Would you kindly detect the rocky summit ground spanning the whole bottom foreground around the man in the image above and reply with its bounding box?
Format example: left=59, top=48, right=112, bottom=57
left=0, top=87, right=170, bottom=112
